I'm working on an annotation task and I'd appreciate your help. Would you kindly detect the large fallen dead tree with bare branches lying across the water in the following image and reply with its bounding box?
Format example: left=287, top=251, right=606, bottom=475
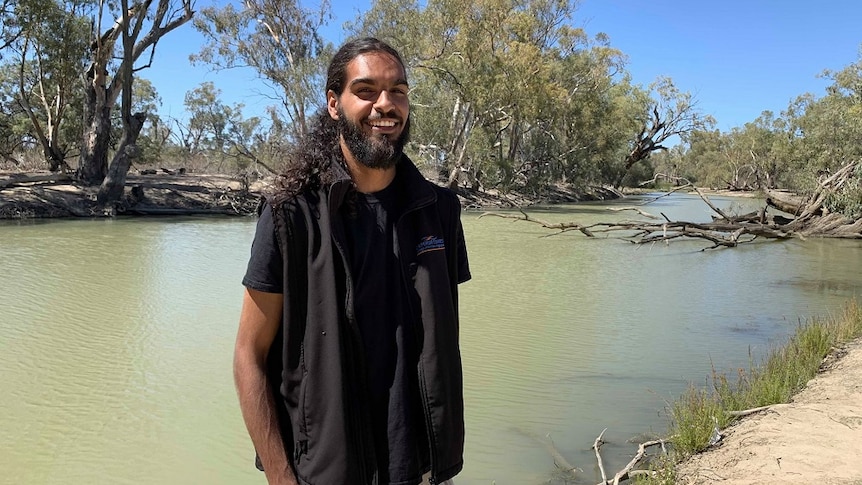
left=479, top=162, right=862, bottom=249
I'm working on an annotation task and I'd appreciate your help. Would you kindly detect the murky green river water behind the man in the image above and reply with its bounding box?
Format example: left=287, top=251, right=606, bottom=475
left=0, top=196, right=862, bottom=485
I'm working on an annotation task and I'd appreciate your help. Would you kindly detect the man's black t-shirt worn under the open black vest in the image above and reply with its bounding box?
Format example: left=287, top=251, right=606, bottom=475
left=243, top=184, right=430, bottom=485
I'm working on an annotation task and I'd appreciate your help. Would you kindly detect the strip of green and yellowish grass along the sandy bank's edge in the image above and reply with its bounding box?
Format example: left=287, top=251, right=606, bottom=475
left=635, top=300, right=862, bottom=485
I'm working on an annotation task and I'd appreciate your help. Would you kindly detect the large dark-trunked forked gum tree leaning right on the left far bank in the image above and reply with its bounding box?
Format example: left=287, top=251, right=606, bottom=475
left=79, top=0, right=194, bottom=196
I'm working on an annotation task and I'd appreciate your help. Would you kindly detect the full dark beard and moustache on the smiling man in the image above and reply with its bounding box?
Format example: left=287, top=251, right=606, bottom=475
left=337, top=108, right=410, bottom=169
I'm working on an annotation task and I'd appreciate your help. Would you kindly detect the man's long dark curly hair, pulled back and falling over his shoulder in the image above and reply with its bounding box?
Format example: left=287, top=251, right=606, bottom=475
left=275, top=37, right=407, bottom=201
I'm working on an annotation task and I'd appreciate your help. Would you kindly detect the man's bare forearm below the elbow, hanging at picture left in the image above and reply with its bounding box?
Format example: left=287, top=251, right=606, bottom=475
left=234, top=355, right=297, bottom=485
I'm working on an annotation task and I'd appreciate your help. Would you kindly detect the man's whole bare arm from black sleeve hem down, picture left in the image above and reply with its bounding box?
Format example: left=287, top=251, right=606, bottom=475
left=233, top=288, right=297, bottom=485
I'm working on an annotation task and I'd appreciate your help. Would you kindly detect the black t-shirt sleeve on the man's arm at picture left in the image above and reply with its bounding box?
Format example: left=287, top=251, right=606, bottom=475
left=242, top=200, right=284, bottom=293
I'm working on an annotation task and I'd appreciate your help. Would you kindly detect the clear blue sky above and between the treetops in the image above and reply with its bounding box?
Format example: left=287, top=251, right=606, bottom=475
left=147, top=0, right=862, bottom=130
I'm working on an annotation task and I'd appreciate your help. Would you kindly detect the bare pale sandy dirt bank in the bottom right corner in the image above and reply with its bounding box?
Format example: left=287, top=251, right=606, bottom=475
left=677, top=340, right=862, bottom=485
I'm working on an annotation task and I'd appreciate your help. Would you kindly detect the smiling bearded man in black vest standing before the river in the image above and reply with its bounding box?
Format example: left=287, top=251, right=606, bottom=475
left=234, top=38, right=470, bottom=485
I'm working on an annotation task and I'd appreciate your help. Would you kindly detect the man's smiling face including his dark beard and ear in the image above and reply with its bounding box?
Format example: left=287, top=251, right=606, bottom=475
left=327, top=52, right=410, bottom=169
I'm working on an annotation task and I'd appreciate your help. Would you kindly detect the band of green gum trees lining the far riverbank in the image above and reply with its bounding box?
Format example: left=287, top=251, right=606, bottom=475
left=0, top=0, right=862, bottom=218
